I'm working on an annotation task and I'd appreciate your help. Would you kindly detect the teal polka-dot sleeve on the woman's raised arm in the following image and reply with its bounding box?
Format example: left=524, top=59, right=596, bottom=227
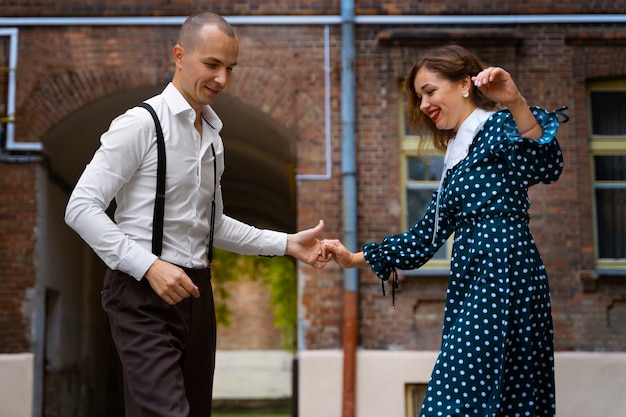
left=492, top=107, right=568, bottom=186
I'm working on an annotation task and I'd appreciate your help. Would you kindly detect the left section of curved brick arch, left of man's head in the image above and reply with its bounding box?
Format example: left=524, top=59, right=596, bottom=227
left=15, top=67, right=165, bottom=142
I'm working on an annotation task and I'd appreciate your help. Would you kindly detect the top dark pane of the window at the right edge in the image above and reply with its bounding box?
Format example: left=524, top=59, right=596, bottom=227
left=590, top=91, right=626, bottom=135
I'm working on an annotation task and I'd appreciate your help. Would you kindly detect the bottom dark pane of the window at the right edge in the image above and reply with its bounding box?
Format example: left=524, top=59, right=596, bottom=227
left=596, top=188, right=626, bottom=259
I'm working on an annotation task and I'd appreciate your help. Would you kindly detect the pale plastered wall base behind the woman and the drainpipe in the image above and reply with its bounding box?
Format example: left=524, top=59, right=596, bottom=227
left=298, top=350, right=626, bottom=417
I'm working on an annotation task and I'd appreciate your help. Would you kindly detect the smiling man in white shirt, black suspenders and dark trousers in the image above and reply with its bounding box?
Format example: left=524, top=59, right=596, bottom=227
left=65, top=12, right=325, bottom=417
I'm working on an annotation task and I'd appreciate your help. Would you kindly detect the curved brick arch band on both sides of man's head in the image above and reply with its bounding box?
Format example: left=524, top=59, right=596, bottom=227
left=22, top=63, right=325, bottom=171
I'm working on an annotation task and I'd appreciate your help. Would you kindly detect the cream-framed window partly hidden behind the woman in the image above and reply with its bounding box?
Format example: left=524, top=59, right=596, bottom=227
left=399, top=89, right=453, bottom=275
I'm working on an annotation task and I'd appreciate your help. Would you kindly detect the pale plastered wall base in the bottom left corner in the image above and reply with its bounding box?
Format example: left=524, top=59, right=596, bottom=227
left=0, top=353, right=33, bottom=417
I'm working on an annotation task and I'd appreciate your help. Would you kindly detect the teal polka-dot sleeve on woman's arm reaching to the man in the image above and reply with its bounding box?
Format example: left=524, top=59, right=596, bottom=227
left=363, top=192, right=452, bottom=281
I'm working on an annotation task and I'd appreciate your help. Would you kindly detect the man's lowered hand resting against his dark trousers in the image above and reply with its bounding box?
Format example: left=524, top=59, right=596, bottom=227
left=145, top=259, right=200, bottom=305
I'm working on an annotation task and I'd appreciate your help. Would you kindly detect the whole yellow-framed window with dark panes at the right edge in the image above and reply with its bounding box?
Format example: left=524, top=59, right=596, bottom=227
left=589, top=81, right=626, bottom=272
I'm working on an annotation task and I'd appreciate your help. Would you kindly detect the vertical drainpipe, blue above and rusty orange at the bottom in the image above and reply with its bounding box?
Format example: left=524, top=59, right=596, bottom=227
left=341, top=0, right=358, bottom=417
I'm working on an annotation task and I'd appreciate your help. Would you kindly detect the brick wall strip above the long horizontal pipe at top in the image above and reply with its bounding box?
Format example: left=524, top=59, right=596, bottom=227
left=0, top=0, right=624, bottom=17
